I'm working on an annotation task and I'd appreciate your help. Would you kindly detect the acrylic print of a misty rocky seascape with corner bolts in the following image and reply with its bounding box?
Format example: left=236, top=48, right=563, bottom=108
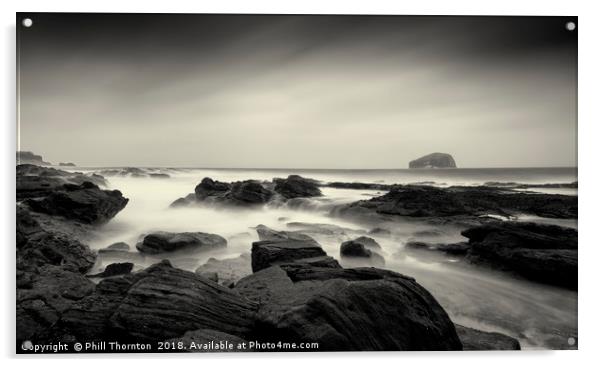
left=16, top=13, right=578, bottom=353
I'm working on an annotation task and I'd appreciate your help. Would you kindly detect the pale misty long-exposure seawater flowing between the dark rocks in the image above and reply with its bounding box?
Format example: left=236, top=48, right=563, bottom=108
left=72, top=168, right=577, bottom=349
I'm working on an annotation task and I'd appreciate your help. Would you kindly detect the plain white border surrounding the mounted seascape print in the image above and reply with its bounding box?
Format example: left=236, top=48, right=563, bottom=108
left=0, top=0, right=602, bottom=367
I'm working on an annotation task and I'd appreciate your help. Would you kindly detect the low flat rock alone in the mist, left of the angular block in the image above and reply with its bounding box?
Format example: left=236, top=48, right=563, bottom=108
left=136, top=231, right=227, bottom=254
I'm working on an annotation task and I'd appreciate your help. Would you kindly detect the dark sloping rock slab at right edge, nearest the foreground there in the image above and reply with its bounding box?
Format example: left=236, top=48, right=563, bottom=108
left=462, top=222, right=577, bottom=289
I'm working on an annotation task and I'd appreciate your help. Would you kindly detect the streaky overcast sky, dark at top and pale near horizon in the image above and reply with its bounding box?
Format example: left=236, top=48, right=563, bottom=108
left=18, top=14, right=577, bottom=168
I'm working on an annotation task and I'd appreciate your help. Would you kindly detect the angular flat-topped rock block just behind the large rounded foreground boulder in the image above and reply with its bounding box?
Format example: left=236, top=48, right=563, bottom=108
left=251, top=225, right=340, bottom=272
